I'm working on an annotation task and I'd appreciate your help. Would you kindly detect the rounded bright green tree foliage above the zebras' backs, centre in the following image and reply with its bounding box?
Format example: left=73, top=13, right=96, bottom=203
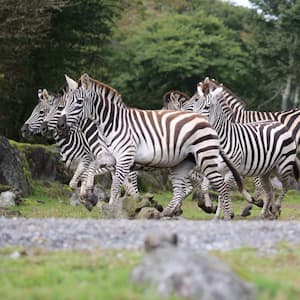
left=112, top=12, right=252, bottom=108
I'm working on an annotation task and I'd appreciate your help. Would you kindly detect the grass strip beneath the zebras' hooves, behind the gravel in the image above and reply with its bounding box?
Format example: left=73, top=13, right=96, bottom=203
left=6, top=181, right=300, bottom=220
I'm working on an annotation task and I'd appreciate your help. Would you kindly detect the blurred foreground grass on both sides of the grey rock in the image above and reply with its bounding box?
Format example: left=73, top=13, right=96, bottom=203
left=0, top=245, right=300, bottom=300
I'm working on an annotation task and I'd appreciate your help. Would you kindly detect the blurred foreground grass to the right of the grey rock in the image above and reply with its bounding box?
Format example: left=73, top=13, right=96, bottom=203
left=215, top=244, right=300, bottom=300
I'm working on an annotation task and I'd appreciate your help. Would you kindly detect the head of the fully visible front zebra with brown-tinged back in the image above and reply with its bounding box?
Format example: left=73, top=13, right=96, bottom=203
left=57, top=74, right=90, bottom=136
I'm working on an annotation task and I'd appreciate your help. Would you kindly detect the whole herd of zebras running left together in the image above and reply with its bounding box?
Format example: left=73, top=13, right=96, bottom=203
left=22, top=74, right=300, bottom=220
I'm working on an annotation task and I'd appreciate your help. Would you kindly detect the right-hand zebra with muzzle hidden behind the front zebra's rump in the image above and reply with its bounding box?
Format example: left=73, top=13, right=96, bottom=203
left=194, top=82, right=299, bottom=217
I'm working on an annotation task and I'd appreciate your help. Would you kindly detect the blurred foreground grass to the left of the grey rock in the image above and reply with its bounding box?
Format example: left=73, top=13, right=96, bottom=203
left=0, top=250, right=159, bottom=300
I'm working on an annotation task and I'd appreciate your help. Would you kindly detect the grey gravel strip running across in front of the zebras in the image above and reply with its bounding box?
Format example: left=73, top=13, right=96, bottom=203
left=0, top=217, right=300, bottom=253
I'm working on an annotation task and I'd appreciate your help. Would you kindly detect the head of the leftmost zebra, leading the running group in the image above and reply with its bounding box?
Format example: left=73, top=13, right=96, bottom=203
left=21, top=89, right=53, bottom=137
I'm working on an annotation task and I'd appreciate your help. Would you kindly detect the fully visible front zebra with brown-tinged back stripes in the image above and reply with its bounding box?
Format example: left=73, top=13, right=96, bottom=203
left=58, top=74, right=243, bottom=219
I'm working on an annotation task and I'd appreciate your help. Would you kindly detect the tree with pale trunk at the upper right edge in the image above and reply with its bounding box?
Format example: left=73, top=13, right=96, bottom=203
left=251, top=0, right=300, bottom=110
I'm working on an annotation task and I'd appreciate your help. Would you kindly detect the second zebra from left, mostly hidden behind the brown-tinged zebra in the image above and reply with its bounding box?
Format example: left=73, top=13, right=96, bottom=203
left=41, top=82, right=140, bottom=210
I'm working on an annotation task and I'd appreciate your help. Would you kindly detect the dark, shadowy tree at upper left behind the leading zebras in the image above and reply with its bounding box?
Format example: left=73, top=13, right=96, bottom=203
left=0, top=0, right=118, bottom=139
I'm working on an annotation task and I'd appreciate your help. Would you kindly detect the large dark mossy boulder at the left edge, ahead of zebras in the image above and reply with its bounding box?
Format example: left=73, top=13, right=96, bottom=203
left=0, top=136, right=32, bottom=196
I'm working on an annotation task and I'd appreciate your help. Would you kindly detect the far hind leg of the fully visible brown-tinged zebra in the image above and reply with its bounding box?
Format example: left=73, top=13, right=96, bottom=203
left=161, top=161, right=195, bottom=217
